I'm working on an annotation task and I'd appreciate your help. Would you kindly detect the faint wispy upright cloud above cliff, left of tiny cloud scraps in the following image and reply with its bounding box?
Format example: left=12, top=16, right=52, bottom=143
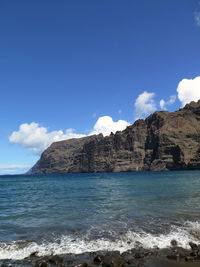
left=135, top=91, right=156, bottom=119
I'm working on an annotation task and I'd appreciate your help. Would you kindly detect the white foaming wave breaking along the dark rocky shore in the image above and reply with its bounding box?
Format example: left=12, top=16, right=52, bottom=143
left=0, top=221, right=200, bottom=260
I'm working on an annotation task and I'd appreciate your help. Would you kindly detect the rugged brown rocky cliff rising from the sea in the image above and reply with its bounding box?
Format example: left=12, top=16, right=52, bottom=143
left=30, top=101, right=200, bottom=174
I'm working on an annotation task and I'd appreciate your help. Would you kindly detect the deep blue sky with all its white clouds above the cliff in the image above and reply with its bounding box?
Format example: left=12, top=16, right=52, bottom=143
left=0, top=0, right=200, bottom=174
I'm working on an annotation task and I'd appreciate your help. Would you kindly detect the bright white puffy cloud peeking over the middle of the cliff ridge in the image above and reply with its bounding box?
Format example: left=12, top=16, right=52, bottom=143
left=89, top=116, right=130, bottom=136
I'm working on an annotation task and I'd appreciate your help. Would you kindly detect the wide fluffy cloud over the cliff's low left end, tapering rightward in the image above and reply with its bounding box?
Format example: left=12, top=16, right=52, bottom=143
left=9, top=122, right=85, bottom=154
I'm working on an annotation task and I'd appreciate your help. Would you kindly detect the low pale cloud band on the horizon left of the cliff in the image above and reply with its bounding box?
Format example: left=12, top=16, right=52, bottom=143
left=0, top=164, right=31, bottom=174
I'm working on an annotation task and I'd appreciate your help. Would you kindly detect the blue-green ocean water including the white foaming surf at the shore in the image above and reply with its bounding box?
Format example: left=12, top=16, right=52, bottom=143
left=0, top=171, right=200, bottom=259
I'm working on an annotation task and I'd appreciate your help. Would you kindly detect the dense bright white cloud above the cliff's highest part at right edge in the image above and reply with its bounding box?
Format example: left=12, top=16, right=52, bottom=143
left=177, top=76, right=200, bottom=106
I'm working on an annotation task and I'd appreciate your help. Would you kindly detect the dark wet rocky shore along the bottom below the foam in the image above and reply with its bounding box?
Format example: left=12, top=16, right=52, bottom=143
left=0, top=240, right=200, bottom=267
